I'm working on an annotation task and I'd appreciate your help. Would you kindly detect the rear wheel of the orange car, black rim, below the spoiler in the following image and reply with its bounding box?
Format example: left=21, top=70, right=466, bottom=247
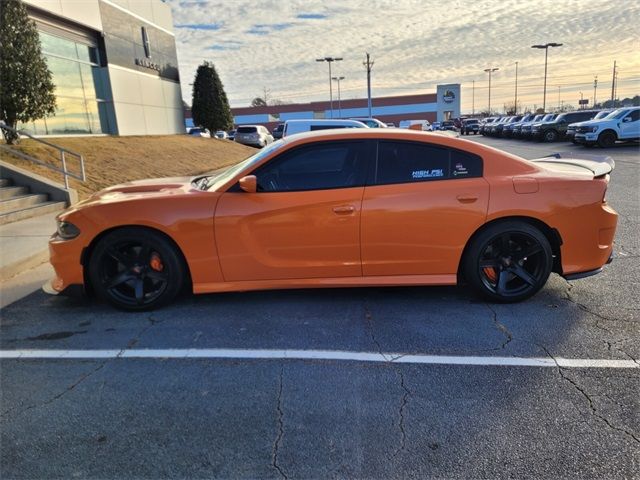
left=463, top=221, right=553, bottom=303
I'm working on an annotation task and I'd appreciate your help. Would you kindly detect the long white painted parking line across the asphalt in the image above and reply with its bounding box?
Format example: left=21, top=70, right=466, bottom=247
left=0, top=348, right=640, bottom=368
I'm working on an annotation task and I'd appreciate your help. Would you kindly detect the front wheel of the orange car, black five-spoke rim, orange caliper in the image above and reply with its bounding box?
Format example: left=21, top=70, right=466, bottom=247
left=89, top=227, right=187, bottom=311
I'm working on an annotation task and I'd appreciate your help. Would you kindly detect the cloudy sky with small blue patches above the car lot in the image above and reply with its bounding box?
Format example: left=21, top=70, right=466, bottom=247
left=167, top=0, right=640, bottom=113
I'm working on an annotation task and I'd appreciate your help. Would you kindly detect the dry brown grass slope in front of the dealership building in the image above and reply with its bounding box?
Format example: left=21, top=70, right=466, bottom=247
left=0, top=135, right=256, bottom=199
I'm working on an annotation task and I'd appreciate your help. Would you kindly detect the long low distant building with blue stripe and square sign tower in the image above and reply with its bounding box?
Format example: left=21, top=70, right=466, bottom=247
left=231, top=83, right=460, bottom=129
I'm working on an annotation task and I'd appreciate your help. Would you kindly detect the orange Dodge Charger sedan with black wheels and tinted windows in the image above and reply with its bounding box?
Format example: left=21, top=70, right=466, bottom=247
left=45, top=129, right=618, bottom=310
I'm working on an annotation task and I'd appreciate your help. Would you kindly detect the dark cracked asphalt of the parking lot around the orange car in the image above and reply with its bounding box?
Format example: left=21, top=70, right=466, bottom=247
left=0, top=133, right=640, bottom=479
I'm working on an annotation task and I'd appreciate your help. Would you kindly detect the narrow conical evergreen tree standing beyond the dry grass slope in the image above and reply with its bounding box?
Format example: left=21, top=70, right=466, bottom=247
left=191, top=62, right=233, bottom=133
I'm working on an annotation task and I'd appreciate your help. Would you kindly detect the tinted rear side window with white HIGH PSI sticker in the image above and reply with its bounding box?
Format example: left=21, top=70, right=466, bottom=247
left=374, top=142, right=482, bottom=185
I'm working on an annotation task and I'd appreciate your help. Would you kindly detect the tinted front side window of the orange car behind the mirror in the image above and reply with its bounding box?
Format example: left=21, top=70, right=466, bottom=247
left=254, top=141, right=368, bottom=192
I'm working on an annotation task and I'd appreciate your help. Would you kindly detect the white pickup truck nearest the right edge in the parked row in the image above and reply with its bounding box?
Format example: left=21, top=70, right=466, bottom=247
left=573, top=107, right=640, bottom=147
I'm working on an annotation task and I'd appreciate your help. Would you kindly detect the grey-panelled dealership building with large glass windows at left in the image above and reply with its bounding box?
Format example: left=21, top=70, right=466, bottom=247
left=20, top=0, right=184, bottom=135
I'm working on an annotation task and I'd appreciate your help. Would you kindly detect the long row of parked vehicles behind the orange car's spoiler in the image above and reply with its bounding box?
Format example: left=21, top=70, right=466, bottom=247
left=460, top=107, right=640, bottom=147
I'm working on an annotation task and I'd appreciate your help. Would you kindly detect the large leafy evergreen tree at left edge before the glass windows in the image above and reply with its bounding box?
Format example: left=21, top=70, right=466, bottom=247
left=0, top=0, right=56, bottom=144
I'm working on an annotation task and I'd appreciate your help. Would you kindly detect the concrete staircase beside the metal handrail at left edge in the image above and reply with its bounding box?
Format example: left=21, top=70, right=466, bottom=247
left=0, top=178, right=66, bottom=225
